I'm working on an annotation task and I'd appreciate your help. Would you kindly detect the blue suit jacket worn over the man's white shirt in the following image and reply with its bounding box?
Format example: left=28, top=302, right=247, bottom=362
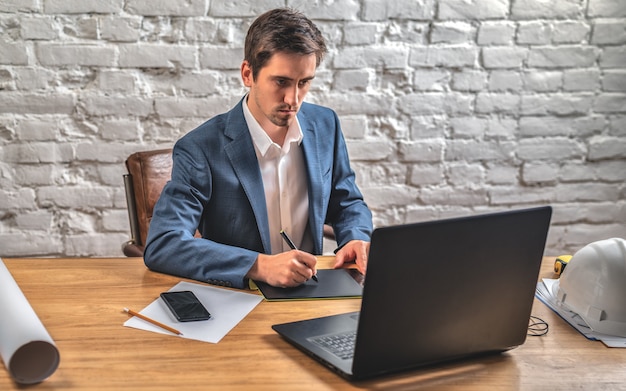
left=144, top=100, right=372, bottom=288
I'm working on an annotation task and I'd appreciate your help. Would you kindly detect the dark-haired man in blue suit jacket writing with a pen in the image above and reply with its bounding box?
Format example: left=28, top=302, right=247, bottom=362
left=144, top=8, right=372, bottom=288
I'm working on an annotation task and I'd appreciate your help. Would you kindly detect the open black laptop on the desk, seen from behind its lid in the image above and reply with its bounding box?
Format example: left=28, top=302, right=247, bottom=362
left=272, top=206, right=552, bottom=380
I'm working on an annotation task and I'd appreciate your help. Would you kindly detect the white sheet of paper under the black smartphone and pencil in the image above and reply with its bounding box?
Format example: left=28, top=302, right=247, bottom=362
left=124, top=281, right=263, bottom=343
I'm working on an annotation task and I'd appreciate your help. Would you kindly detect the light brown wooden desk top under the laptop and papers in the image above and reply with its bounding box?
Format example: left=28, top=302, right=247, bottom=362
left=0, top=258, right=626, bottom=391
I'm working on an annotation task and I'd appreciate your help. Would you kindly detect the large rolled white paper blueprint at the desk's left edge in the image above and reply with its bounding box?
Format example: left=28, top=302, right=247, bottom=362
left=0, top=259, right=60, bottom=384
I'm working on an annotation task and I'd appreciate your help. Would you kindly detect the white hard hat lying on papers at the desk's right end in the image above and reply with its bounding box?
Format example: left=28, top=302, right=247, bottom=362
left=555, top=238, right=626, bottom=337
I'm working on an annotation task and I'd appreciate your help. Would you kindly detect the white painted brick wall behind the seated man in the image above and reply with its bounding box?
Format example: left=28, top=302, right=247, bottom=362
left=0, top=0, right=626, bottom=257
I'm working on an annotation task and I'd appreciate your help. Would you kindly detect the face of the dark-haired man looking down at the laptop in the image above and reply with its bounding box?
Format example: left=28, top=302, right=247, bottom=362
left=241, top=52, right=316, bottom=137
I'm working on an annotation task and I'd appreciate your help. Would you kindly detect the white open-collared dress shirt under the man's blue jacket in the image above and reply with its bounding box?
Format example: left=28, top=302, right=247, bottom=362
left=243, top=98, right=310, bottom=254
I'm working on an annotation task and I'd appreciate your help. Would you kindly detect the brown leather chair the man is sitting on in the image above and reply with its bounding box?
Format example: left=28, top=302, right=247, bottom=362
left=122, top=149, right=335, bottom=257
